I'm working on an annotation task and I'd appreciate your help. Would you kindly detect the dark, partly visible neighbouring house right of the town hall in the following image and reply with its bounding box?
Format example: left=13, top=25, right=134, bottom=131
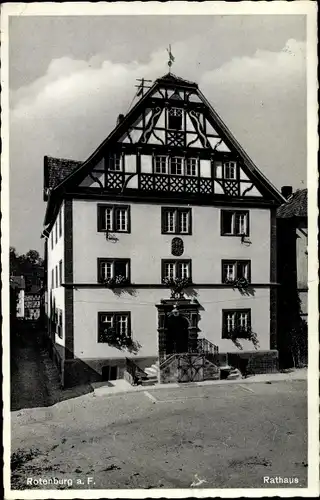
left=277, top=186, right=308, bottom=365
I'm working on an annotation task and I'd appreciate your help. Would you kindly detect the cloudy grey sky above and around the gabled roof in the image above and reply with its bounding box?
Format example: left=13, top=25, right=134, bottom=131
left=9, top=15, right=307, bottom=254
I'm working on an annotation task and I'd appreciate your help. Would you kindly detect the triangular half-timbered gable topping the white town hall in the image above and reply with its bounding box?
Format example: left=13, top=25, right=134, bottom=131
left=43, top=74, right=283, bottom=204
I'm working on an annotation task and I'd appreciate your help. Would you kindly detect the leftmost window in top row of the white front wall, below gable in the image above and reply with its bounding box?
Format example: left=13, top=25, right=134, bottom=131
left=98, top=205, right=130, bottom=233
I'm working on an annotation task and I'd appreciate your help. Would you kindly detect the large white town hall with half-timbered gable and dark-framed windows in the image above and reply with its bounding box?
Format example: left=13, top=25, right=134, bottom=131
left=44, top=74, right=284, bottom=386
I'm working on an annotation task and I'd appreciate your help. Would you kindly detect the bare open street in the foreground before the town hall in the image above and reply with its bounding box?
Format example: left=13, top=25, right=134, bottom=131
left=12, top=381, right=308, bottom=489
